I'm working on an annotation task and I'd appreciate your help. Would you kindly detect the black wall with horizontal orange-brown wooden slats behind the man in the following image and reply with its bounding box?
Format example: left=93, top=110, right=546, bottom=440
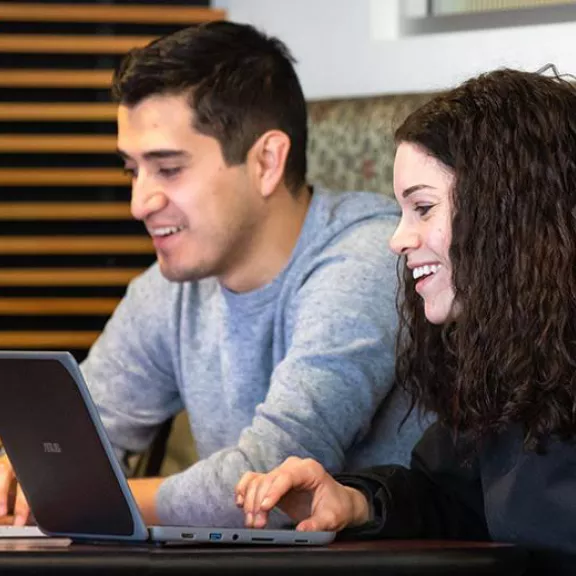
left=0, top=0, right=225, bottom=359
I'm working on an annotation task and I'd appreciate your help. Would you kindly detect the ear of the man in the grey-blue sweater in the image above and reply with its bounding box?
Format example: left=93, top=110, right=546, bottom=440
left=248, top=130, right=290, bottom=198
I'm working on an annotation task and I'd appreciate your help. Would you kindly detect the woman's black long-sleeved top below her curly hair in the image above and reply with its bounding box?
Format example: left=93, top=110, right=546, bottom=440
left=337, top=424, right=576, bottom=574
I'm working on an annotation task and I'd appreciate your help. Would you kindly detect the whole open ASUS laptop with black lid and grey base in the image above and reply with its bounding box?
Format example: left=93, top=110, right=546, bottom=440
left=0, top=351, right=335, bottom=546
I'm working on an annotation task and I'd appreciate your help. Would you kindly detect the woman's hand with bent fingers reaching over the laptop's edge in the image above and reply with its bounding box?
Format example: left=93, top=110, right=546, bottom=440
left=236, top=457, right=370, bottom=531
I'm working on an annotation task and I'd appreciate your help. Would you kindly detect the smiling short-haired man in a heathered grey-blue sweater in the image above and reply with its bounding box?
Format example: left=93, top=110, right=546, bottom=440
left=0, top=22, right=428, bottom=526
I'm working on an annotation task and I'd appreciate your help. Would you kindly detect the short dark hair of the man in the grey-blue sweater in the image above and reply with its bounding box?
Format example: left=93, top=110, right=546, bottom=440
left=112, top=22, right=308, bottom=192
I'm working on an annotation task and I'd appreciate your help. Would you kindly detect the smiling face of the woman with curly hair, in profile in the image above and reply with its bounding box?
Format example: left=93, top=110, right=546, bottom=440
left=390, top=142, right=456, bottom=324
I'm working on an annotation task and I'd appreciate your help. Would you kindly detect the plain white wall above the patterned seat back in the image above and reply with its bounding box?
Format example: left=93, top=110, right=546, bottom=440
left=213, top=0, right=576, bottom=100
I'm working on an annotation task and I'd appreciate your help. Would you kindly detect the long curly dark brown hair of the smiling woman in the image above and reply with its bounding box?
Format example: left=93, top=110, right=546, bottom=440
left=396, top=70, right=576, bottom=449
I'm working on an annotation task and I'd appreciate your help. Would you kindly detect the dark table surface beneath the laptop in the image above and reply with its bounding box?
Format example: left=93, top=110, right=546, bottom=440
left=0, top=540, right=527, bottom=576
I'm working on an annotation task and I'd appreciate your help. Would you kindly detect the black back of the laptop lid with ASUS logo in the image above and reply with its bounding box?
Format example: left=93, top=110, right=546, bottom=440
left=0, top=353, right=134, bottom=537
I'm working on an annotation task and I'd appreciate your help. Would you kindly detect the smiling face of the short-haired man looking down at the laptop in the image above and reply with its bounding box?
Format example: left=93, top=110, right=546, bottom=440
left=118, top=95, right=262, bottom=282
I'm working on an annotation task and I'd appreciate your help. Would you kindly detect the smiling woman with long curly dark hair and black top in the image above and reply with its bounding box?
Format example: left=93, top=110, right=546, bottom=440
left=236, top=70, right=576, bottom=568
